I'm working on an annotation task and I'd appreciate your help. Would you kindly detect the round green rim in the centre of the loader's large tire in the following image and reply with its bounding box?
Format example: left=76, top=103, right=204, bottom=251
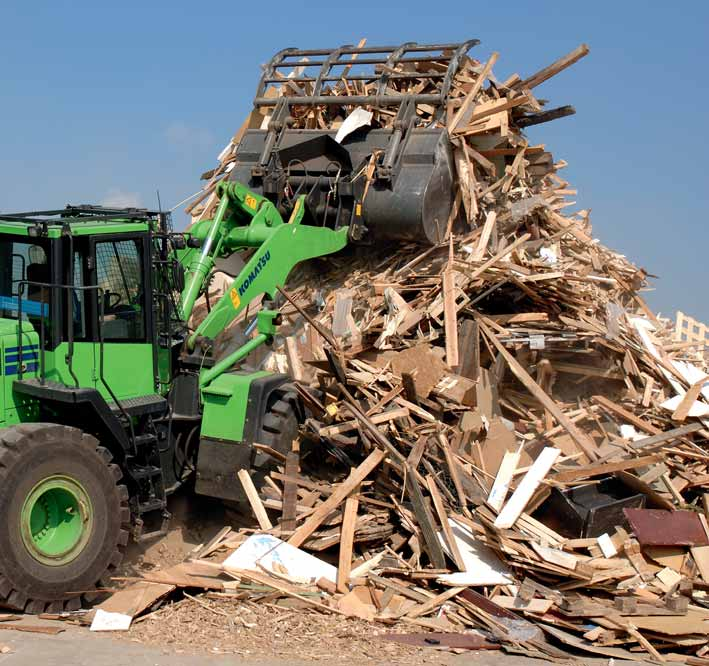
left=21, top=474, right=94, bottom=566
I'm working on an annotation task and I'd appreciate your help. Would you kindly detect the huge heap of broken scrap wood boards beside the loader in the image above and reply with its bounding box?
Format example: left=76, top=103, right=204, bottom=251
left=123, top=41, right=709, bottom=664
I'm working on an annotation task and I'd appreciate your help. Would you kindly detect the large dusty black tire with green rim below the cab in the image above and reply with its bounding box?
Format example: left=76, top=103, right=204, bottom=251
left=0, top=423, right=130, bottom=613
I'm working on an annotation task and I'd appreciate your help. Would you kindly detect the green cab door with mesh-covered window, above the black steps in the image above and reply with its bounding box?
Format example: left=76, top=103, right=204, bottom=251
left=91, top=233, right=155, bottom=402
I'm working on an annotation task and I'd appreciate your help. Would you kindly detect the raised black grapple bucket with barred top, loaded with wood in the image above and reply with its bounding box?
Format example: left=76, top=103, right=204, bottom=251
left=230, top=40, right=478, bottom=243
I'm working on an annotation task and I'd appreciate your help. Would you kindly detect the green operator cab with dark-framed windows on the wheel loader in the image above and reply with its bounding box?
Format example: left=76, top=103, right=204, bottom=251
left=0, top=224, right=156, bottom=401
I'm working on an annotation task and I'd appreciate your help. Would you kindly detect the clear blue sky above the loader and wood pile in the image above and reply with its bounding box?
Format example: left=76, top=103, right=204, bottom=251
left=0, top=0, right=709, bottom=321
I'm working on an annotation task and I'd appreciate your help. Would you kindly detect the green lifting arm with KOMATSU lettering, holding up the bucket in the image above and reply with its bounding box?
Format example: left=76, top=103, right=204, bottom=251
left=180, top=182, right=348, bottom=386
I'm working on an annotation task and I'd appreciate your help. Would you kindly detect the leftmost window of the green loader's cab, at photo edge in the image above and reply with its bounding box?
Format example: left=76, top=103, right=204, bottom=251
left=0, top=235, right=52, bottom=320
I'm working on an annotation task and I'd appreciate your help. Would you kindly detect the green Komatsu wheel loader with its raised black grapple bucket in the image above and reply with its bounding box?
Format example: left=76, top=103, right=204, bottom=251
left=0, top=42, right=474, bottom=613
